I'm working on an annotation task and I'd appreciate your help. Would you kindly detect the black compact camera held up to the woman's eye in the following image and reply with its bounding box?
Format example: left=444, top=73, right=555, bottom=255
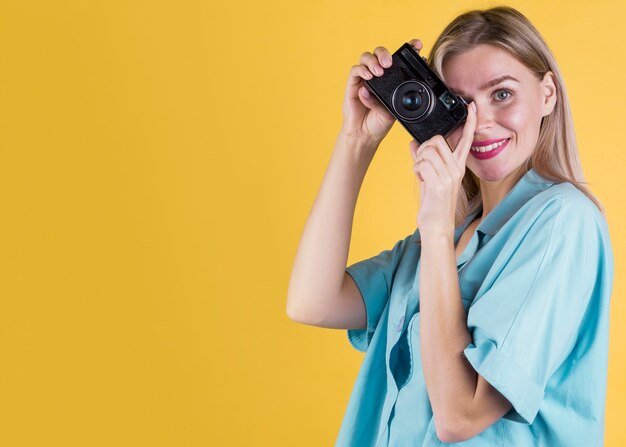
left=365, top=43, right=467, bottom=143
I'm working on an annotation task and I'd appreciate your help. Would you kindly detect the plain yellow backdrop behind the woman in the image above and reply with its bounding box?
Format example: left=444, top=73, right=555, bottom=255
left=0, top=0, right=626, bottom=447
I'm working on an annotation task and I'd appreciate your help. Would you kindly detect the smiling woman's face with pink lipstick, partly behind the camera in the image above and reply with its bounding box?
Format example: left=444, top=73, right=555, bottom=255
left=443, top=44, right=556, bottom=182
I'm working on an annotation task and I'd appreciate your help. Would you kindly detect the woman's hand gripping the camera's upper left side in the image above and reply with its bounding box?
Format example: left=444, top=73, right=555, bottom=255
left=341, top=39, right=422, bottom=146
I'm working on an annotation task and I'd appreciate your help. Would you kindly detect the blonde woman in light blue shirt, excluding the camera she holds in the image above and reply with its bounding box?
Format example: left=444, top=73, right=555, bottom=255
left=287, top=7, right=613, bottom=446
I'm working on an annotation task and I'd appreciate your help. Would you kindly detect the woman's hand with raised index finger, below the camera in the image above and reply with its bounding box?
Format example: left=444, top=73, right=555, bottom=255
left=409, top=103, right=476, bottom=235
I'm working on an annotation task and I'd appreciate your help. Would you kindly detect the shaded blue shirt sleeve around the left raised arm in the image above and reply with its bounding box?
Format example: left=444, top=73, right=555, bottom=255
left=346, top=234, right=413, bottom=352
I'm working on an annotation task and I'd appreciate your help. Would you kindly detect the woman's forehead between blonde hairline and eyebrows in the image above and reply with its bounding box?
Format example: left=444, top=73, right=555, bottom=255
left=442, top=44, right=534, bottom=93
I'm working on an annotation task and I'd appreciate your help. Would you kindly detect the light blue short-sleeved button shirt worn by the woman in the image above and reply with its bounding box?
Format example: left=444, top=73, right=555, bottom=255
left=336, top=169, right=613, bottom=447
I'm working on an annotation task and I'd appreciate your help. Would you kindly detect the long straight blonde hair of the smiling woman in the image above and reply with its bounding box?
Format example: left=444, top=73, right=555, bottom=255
left=429, top=6, right=605, bottom=226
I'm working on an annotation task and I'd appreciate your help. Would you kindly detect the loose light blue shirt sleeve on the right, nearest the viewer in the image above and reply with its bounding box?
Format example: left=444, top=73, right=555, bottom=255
left=464, top=196, right=610, bottom=424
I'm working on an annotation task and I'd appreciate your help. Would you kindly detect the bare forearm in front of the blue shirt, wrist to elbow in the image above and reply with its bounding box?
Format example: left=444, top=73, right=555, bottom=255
left=419, top=232, right=478, bottom=432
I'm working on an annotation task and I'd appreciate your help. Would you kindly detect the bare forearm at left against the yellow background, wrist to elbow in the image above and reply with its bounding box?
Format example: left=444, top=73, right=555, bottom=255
left=287, top=134, right=376, bottom=322
